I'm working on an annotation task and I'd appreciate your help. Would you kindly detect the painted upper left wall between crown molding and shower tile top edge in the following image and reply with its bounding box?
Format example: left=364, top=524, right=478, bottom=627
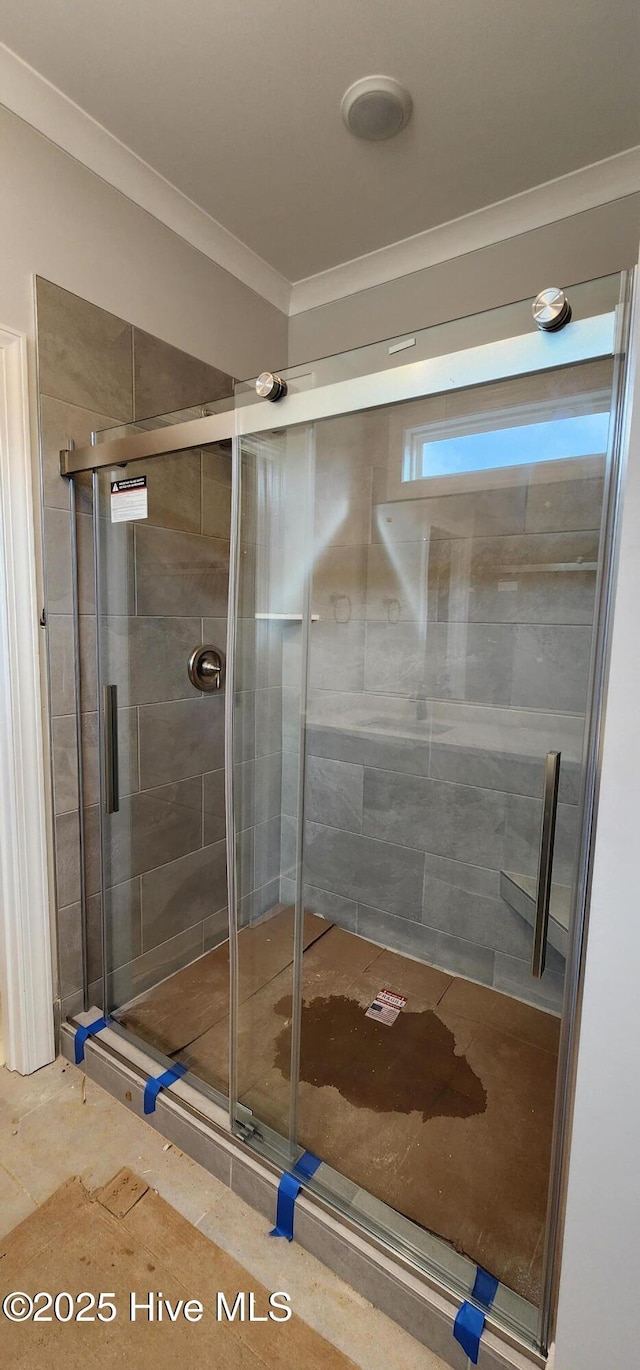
left=0, top=107, right=286, bottom=377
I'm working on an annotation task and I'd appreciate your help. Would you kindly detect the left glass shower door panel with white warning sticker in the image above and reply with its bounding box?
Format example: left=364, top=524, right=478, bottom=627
left=92, top=444, right=232, bottom=1096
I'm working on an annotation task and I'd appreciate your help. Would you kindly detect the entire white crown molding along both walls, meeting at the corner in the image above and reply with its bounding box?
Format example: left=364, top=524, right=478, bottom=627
left=0, top=42, right=640, bottom=323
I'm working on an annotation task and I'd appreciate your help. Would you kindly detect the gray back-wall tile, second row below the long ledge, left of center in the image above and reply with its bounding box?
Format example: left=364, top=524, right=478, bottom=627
left=304, top=823, right=425, bottom=919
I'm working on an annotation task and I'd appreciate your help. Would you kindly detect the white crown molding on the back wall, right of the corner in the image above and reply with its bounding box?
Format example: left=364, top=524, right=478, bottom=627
left=289, top=147, right=640, bottom=315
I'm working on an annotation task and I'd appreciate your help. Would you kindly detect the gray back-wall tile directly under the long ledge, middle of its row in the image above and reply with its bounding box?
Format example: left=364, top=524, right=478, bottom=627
left=363, top=767, right=506, bottom=870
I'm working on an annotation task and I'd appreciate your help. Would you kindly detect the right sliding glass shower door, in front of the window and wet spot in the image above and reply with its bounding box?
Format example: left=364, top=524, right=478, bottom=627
left=234, top=283, right=627, bottom=1344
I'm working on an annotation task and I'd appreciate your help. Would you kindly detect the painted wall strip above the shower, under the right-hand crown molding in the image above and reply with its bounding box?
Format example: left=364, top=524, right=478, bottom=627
left=289, top=195, right=640, bottom=363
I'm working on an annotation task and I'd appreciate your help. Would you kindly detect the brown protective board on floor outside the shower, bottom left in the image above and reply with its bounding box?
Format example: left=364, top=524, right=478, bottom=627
left=0, top=1171, right=354, bottom=1370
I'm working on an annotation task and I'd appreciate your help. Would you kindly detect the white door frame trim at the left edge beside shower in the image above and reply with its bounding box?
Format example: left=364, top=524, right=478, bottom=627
left=0, top=327, right=55, bottom=1075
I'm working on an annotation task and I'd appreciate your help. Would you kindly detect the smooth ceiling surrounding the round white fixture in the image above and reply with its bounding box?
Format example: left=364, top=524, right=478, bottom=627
left=0, top=0, right=640, bottom=281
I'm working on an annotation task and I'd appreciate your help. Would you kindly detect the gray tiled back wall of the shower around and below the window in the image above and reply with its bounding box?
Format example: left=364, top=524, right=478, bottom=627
left=281, top=380, right=606, bottom=1008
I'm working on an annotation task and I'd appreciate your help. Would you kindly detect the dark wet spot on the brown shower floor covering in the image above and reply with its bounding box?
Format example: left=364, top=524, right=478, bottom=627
left=269, top=995, right=487, bottom=1122
